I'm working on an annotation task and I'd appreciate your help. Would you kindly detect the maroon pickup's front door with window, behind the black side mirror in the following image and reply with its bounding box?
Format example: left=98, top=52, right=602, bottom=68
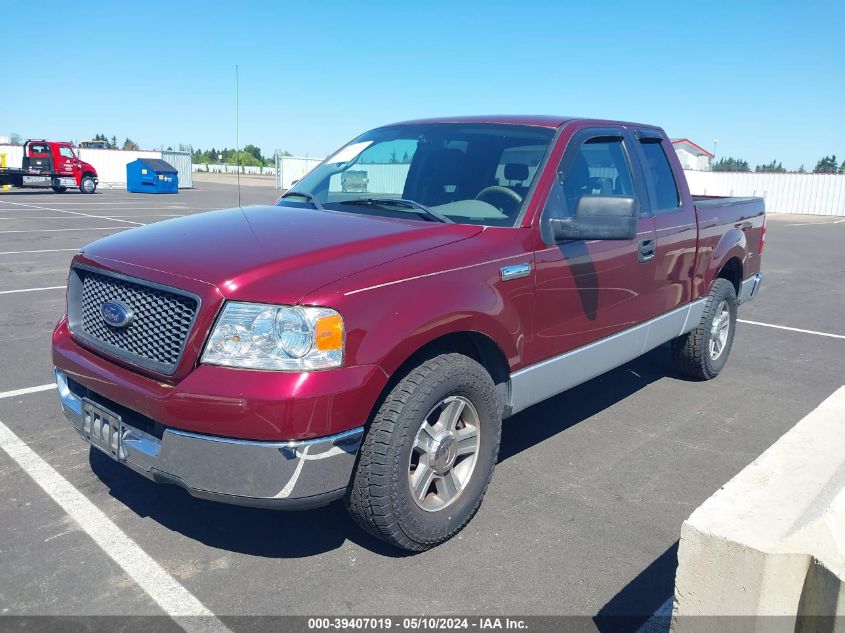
left=532, top=128, right=655, bottom=360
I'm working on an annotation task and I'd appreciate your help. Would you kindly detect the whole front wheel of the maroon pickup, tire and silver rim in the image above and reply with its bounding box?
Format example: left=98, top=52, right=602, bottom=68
left=346, top=354, right=502, bottom=551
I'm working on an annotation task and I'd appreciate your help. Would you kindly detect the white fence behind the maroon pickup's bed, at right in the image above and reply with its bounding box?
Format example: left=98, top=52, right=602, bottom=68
left=684, top=171, right=845, bottom=216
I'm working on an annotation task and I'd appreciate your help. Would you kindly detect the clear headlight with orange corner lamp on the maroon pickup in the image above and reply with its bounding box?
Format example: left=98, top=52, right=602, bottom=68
left=201, top=301, right=344, bottom=371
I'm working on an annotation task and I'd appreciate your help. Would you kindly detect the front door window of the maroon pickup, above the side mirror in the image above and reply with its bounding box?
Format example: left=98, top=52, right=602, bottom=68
left=546, top=136, right=636, bottom=218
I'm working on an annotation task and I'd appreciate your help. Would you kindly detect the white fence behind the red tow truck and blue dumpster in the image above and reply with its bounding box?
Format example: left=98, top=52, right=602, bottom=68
left=0, top=145, right=193, bottom=189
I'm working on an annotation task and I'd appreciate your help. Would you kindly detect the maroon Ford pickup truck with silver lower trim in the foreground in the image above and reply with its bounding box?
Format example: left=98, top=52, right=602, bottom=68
left=53, top=116, right=765, bottom=550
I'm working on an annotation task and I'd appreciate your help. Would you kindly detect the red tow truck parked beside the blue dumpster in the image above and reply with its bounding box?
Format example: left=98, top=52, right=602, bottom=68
left=0, top=140, right=99, bottom=193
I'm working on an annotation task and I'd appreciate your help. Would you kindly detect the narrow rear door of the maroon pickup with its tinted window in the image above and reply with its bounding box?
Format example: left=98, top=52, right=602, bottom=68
left=633, top=130, right=698, bottom=315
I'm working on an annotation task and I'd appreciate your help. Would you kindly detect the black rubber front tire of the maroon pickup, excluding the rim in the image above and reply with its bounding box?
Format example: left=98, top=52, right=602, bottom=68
left=346, top=354, right=502, bottom=552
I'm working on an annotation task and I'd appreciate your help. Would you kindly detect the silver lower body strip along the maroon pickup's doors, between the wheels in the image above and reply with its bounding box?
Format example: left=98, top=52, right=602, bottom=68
left=511, top=299, right=706, bottom=413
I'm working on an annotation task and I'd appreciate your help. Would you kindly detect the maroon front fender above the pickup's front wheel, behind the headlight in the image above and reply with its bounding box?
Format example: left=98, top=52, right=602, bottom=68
left=303, top=229, right=534, bottom=375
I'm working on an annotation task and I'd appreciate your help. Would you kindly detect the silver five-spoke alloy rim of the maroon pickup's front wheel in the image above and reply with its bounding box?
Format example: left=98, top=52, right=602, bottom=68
left=408, top=396, right=481, bottom=512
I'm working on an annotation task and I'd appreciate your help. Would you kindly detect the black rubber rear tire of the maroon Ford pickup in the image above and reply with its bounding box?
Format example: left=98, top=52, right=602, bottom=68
left=672, top=279, right=737, bottom=380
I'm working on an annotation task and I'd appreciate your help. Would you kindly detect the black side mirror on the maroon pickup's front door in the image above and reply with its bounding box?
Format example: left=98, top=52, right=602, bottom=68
left=549, top=196, right=639, bottom=242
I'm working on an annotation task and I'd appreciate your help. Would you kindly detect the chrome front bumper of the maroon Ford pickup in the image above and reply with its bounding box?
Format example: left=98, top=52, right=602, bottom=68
left=56, top=369, right=364, bottom=509
